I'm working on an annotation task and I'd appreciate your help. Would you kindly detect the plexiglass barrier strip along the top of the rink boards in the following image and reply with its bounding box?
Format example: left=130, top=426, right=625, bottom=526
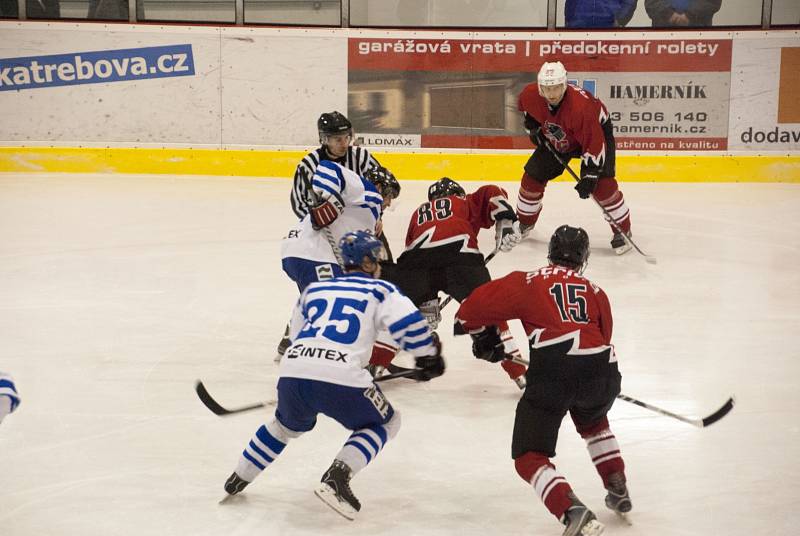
left=0, top=0, right=800, bottom=30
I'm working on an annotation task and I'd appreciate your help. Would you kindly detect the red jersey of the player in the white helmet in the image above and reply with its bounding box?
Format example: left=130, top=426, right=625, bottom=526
left=519, top=83, right=608, bottom=174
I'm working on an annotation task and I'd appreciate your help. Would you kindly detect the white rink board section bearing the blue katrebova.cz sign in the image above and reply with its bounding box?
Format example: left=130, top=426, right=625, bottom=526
left=0, top=21, right=221, bottom=145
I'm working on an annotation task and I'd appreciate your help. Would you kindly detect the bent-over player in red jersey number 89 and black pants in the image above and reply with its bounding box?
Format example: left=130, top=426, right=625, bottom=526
left=372, top=177, right=525, bottom=389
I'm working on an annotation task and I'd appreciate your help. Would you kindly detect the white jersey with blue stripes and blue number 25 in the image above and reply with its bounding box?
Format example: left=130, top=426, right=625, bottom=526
left=280, top=272, right=436, bottom=387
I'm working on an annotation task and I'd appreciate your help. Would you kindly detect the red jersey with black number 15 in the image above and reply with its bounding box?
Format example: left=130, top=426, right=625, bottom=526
left=456, top=265, right=616, bottom=362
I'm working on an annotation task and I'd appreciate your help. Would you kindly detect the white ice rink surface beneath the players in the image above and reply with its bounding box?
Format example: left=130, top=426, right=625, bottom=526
left=0, top=174, right=800, bottom=536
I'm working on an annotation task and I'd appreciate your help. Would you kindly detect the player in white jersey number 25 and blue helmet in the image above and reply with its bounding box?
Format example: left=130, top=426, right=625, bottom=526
left=225, top=231, right=444, bottom=520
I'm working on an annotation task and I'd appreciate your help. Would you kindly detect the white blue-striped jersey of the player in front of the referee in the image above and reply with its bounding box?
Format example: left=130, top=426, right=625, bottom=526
left=281, top=160, right=383, bottom=263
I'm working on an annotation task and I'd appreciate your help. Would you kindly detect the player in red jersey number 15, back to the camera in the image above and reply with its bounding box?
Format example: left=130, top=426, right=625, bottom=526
left=456, top=225, right=631, bottom=536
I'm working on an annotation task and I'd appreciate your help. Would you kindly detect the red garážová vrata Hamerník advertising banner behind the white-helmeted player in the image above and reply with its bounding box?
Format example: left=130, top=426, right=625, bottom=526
left=348, top=37, right=732, bottom=151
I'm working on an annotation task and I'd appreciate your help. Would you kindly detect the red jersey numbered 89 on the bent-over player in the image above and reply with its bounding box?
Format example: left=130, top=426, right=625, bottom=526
left=406, top=184, right=515, bottom=253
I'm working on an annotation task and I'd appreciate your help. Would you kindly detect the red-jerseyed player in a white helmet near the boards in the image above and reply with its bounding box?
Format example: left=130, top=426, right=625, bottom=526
left=517, top=61, right=631, bottom=255
